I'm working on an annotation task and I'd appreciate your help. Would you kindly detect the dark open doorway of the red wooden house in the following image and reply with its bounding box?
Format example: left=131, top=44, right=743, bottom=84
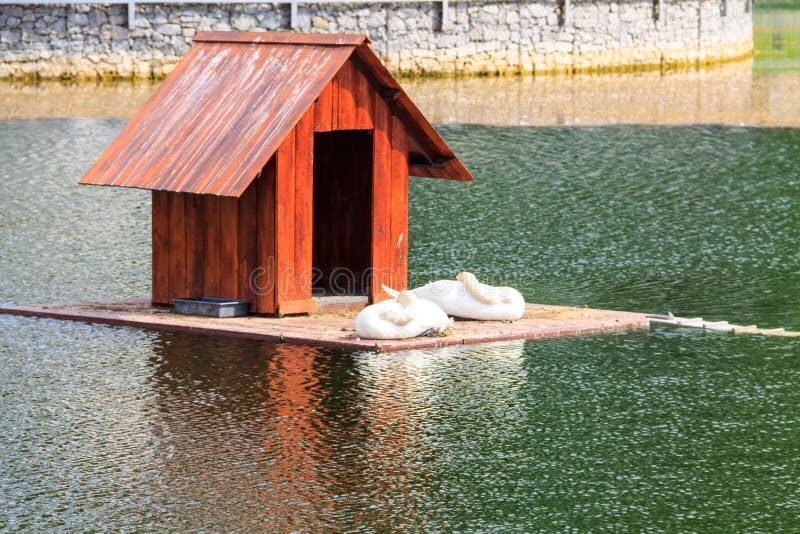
left=313, top=130, right=372, bottom=296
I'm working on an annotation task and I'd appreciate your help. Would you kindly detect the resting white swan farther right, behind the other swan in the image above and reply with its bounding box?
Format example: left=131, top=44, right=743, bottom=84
left=406, top=272, right=525, bottom=321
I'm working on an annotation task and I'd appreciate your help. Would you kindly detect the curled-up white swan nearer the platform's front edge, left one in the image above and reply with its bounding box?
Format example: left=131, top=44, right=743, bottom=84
left=356, top=286, right=453, bottom=339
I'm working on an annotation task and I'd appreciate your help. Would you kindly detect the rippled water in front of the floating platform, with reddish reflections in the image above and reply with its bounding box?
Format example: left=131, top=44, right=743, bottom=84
left=0, top=326, right=800, bottom=532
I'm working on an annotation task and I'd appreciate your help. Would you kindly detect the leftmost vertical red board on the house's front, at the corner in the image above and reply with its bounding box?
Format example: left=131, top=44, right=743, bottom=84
left=275, top=129, right=295, bottom=307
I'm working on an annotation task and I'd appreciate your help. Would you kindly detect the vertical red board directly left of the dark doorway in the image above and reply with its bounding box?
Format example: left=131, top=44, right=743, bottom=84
left=293, top=110, right=314, bottom=300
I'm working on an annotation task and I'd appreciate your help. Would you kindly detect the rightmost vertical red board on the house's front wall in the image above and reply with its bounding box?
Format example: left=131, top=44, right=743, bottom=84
left=389, top=116, right=408, bottom=294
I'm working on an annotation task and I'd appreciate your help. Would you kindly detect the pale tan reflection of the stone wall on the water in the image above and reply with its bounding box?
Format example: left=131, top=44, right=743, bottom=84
left=0, top=58, right=800, bottom=127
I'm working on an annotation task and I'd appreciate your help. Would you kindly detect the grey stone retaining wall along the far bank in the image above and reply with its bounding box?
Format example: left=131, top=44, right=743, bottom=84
left=0, top=0, right=752, bottom=78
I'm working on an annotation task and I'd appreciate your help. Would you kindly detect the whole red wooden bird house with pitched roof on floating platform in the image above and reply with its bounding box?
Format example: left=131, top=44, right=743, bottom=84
left=81, top=32, right=472, bottom=315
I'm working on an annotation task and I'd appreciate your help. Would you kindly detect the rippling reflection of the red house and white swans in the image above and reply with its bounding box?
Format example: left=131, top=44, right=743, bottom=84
left=150, top=333, right=523, bottom=530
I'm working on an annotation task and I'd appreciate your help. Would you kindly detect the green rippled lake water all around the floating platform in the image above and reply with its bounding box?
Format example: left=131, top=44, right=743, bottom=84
left=0, top=115, right=800, bottom=532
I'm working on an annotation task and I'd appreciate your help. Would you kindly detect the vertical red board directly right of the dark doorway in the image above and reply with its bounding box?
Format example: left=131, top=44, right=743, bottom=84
left=370, top=93, right=392, bottom=302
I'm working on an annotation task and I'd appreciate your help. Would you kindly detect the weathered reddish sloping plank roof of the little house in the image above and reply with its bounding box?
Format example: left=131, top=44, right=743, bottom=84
left=81, top=32, right=472, bottom=197
